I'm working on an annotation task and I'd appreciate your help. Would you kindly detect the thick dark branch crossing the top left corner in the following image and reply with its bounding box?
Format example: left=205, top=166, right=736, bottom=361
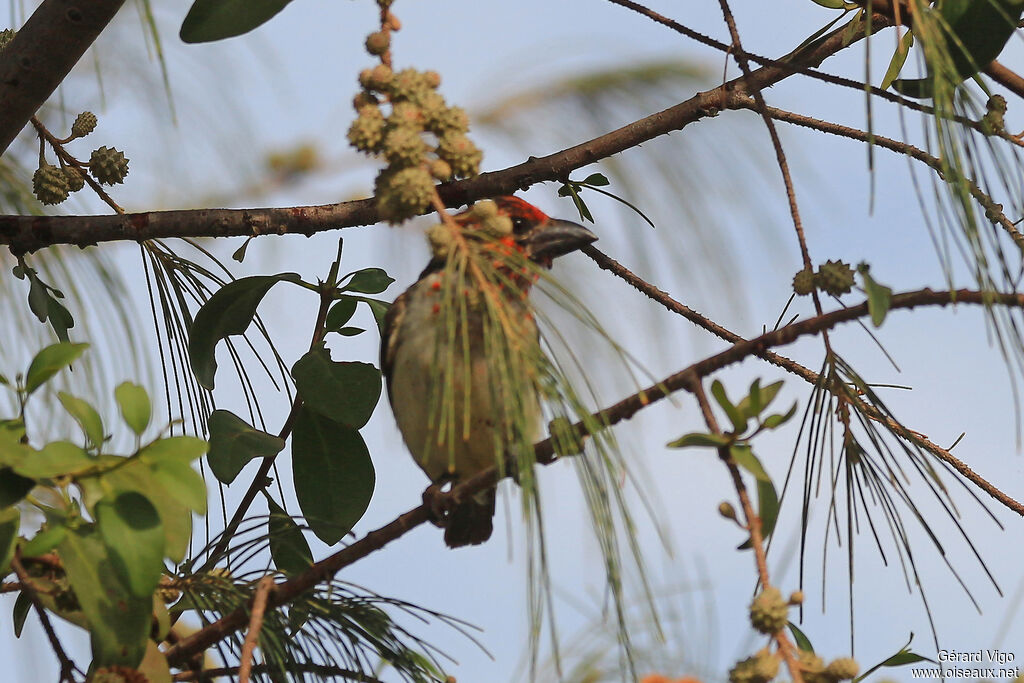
left=0, top=0, right=124, bottom=155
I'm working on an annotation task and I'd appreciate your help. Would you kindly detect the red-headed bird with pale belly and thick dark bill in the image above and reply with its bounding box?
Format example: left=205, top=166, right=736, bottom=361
left=381, top=197, right=597, bottom=548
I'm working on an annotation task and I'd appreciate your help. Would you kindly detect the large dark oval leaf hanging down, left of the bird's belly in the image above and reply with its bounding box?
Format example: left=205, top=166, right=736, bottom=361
left=292, top=408, right=375, bottom=545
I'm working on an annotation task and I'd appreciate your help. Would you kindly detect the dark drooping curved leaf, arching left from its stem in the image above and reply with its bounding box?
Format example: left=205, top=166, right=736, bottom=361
left=188, top=272, right=300, bottom=389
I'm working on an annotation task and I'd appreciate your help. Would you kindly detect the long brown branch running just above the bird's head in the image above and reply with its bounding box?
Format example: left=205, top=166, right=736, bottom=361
left=0, top=18, right=882, bottom=254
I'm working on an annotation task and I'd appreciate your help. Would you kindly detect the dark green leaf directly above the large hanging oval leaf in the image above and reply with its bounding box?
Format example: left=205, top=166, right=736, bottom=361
left=292, top=347, right=381, bottom=429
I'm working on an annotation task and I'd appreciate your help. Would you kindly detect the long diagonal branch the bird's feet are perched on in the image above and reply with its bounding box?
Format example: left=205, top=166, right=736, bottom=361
left=166, top=289, right=1024, bottom=667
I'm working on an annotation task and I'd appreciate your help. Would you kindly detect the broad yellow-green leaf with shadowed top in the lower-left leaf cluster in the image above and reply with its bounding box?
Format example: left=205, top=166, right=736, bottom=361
left=96, top=490, right=164, bottom=598
